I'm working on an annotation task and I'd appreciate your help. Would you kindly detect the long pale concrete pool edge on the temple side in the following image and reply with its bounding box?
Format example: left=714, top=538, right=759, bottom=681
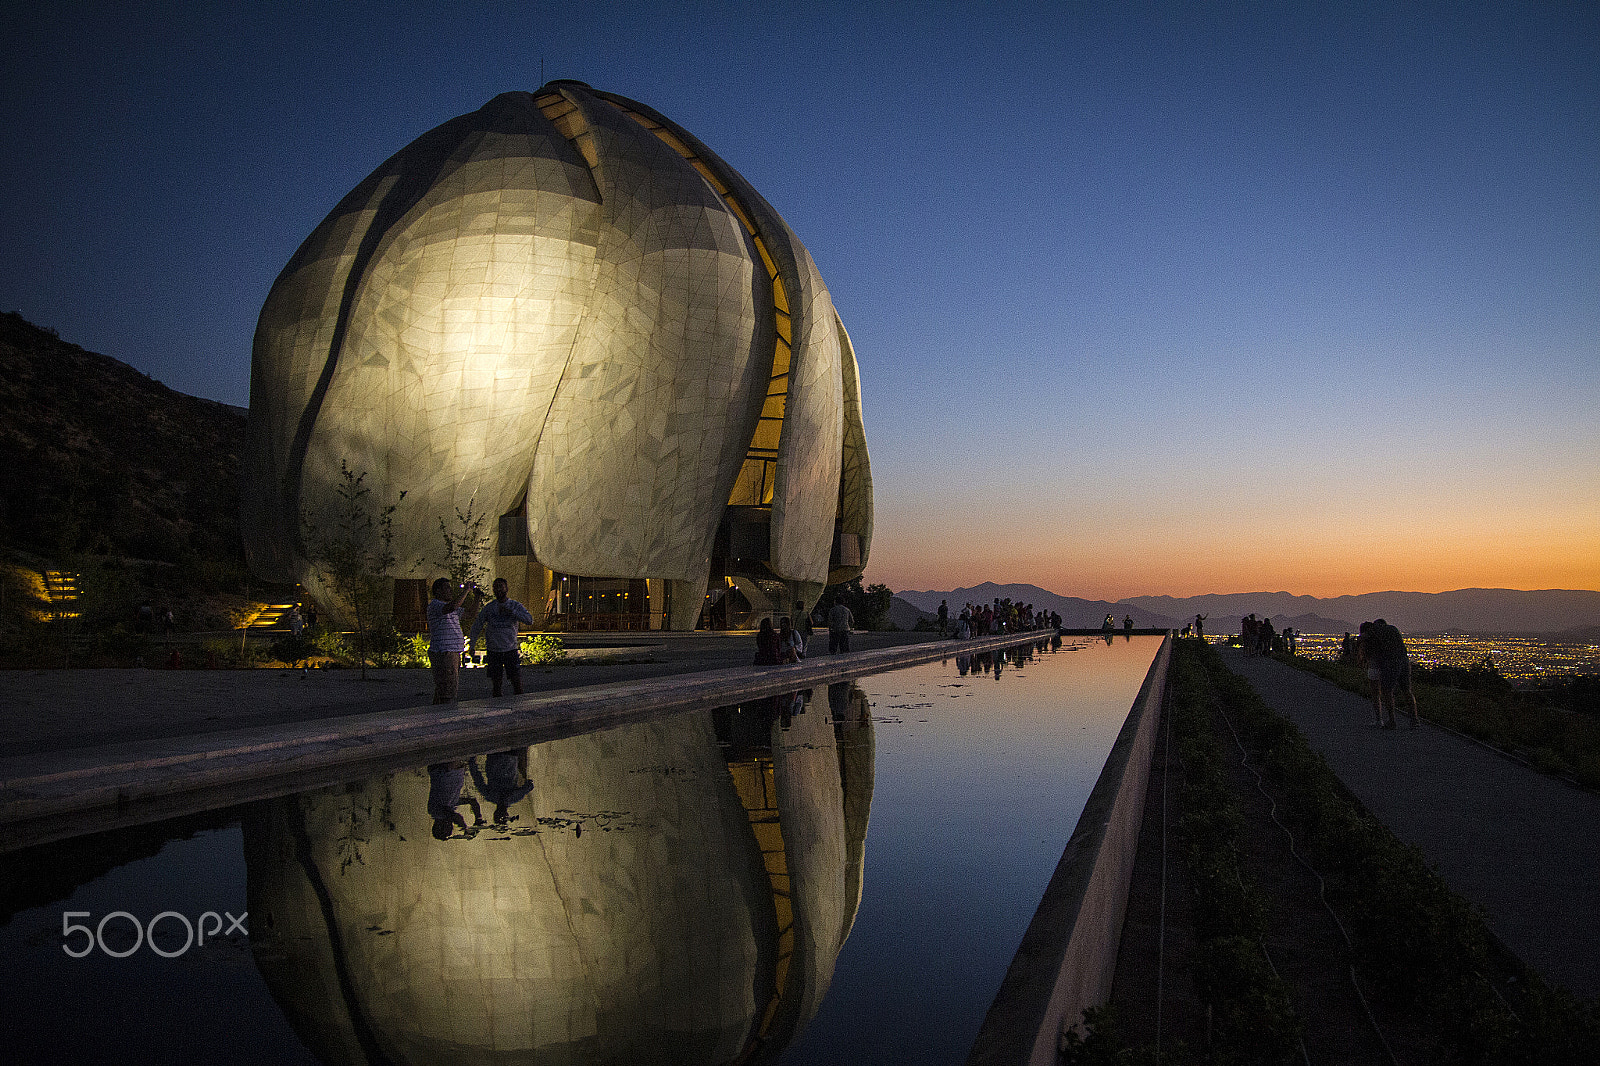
left=0, top=629, right=1056, bottom=852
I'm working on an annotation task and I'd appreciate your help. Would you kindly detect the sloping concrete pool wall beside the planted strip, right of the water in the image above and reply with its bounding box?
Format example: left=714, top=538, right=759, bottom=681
left=966, top=632, right=1173, bottom=1066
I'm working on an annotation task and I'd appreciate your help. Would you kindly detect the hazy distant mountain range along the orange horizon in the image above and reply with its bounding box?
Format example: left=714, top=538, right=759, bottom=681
left=896, top=581, right=1600, bottom=630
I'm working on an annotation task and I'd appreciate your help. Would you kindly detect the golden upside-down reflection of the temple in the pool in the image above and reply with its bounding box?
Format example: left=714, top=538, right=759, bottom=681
left=245, top=683, right=874, bottom=1063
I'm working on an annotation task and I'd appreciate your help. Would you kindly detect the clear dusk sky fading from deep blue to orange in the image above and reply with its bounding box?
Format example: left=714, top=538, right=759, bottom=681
left=0, top=3, right=1600, bottom=599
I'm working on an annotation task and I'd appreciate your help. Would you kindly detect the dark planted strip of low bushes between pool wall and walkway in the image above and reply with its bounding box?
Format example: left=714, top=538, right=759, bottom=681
left=1062, top=640, right=1600, bottom=1066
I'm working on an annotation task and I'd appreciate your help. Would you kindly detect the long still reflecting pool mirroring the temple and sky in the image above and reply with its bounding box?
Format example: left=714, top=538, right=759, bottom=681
left=0, top=637, right=1160, bottom=1064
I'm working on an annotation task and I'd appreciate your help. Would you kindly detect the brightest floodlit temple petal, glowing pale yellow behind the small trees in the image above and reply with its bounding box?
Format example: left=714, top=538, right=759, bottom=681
left=306, top=112, right=600, bottom=562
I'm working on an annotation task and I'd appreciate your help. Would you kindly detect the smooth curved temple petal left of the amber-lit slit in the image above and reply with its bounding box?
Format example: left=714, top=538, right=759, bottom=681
left=528, top=88, right=771, bottom=579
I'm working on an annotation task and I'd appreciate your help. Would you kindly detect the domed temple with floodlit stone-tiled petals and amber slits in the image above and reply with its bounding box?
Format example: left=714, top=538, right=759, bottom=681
left=243, top=82, right=872, bottom=629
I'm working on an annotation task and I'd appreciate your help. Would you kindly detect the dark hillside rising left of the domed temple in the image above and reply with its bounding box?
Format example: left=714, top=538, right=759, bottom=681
left=0, top=314, right=245, bottom=573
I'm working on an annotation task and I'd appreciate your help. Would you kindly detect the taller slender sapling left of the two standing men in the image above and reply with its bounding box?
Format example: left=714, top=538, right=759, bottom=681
left=302, top=459, right=405, bottom=680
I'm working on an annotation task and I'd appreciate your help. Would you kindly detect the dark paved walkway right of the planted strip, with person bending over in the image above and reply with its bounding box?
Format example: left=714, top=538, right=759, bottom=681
left=1222, top=648, right=1600, bottom=996
